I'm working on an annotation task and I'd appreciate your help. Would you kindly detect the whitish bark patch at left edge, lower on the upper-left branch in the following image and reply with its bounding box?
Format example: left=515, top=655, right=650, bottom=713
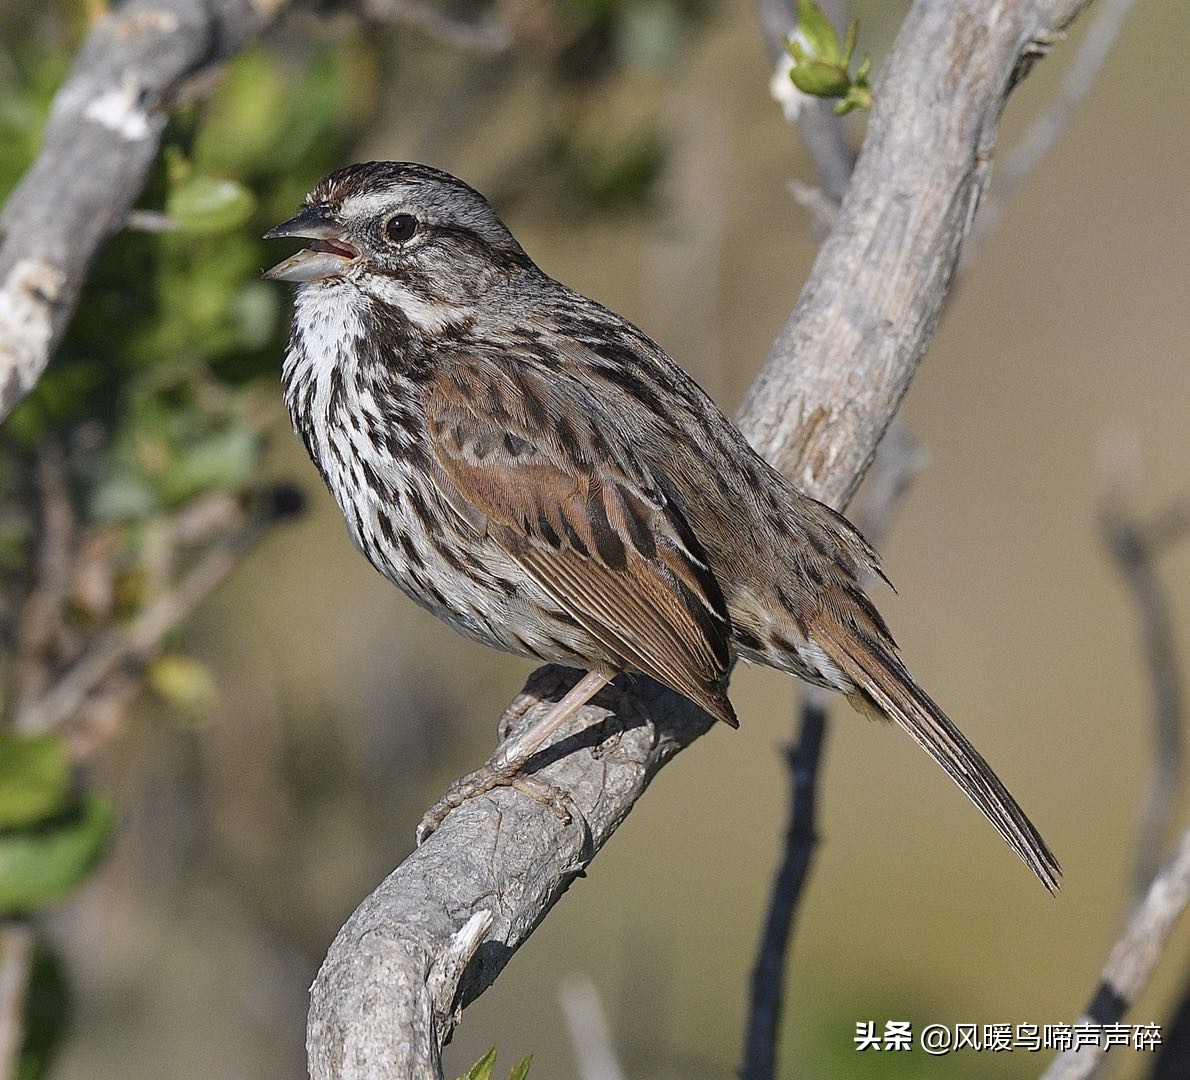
left=0, top=259, right=65, bottom=409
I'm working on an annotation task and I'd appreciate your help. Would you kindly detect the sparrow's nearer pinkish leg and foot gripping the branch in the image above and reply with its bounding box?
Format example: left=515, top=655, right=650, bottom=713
left=418, top=671, right=610, bottom=846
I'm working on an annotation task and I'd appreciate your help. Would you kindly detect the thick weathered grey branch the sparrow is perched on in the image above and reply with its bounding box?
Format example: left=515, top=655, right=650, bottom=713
left=307, top=0, right=1086, bottom=1080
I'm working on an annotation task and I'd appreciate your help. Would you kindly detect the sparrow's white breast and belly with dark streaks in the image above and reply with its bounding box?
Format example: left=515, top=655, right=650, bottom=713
left=283, top=283, right=590, bottom=663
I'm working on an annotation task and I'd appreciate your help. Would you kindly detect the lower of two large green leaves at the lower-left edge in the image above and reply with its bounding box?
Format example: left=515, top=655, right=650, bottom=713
left=0, top=796, right=114, bottom=915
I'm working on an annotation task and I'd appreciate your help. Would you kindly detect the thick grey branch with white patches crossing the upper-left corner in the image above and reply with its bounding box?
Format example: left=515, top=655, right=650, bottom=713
left=0, top=0, right=287, bottom=420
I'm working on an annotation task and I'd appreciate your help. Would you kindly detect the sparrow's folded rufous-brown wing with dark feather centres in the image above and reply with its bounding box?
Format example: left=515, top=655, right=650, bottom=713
left=421, top=358, right=737, bottom=727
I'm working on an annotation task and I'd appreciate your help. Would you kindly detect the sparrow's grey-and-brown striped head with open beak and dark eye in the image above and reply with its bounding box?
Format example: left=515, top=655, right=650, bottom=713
left=264, top=162, right=532, bottom=307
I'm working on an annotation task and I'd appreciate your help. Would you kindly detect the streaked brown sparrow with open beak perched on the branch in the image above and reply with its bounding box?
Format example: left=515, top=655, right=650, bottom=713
left=265, top=162, right=1059, bottom=891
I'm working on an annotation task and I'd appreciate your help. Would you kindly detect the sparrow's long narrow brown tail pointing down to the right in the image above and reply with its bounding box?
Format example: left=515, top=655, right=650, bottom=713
left=814, top=619, right=1061, bottom=892
